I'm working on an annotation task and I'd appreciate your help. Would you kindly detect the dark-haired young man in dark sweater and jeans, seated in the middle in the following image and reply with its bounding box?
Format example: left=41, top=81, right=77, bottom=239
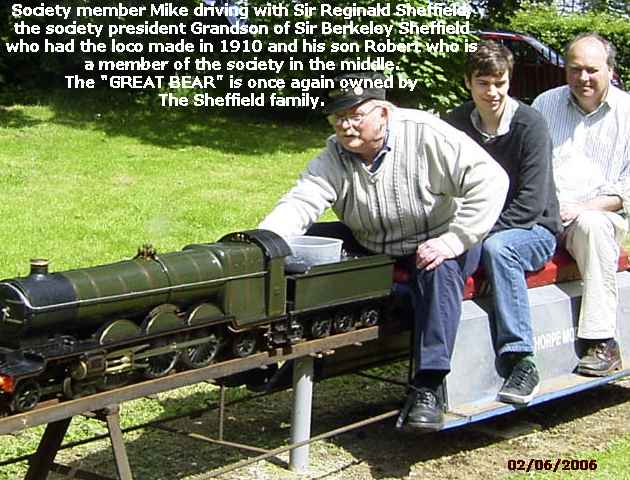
left=446, top=42, right=562, bottom=403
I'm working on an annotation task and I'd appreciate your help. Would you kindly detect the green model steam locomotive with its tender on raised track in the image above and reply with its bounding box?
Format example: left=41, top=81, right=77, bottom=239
left=0, top=230, right=393, bottom=413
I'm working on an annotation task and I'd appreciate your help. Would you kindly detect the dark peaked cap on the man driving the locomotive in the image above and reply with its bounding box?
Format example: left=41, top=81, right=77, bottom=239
left=323, top=72, right=385, bottom=114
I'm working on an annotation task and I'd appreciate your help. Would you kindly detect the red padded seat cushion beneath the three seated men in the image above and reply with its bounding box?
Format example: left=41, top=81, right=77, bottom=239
left=394, top=248, right=630, bottom=300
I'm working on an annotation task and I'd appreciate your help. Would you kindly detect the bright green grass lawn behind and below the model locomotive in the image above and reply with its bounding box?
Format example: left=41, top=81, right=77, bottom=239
left=0, top=92, right=630, bottom=480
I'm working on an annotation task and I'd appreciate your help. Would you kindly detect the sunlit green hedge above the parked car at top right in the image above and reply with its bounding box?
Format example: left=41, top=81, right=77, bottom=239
left=508, top=4, right=630, bottom=88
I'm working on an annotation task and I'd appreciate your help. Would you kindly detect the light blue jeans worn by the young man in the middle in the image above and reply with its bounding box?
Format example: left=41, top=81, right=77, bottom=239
left=482, top=225, right=556, bottom=355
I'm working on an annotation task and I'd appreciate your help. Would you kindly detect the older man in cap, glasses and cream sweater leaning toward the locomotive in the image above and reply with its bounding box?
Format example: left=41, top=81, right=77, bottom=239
left=260, top=73, right=508, bottom=430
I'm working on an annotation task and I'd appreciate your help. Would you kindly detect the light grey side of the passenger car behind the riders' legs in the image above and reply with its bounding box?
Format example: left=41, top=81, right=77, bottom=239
left=446, top=272, right=630, bottom=408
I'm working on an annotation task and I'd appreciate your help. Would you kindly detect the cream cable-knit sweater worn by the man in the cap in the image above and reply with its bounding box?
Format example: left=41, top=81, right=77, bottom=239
left=259, top=108, right=508, bottom=256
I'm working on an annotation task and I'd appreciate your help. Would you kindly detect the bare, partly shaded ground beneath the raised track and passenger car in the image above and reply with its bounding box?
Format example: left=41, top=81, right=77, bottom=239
left=37, top=368, right=630, bottom=480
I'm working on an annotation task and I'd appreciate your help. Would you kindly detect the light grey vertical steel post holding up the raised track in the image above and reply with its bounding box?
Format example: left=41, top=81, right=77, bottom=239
left=289, top=357, right=313, bottom=473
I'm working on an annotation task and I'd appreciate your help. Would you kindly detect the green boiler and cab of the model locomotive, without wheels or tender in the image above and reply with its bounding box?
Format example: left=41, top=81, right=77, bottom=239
left=0, top=235, right=267, bottom=345
